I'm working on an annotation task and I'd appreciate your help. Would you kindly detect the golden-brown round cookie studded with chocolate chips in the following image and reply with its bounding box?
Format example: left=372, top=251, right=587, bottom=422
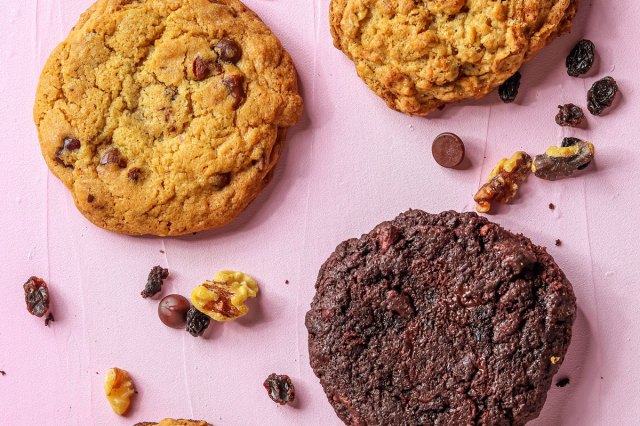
left=34, top=0, right=302, bottom=235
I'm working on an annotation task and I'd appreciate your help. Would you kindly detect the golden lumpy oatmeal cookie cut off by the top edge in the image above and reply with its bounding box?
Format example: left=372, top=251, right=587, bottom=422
left=330, top=0, right=578, bottom=115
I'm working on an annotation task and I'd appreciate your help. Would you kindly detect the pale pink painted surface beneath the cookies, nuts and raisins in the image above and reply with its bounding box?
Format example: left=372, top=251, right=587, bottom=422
left=0, top=0, right=640, bottom=425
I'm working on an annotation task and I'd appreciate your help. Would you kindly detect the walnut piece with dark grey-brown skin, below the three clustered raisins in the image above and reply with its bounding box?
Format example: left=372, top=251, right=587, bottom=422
left=531, top=141, right=595, bottom=180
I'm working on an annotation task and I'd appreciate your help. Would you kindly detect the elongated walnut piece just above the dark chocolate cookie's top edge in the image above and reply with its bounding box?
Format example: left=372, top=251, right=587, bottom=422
left=473, top=151, right=531, bottom=213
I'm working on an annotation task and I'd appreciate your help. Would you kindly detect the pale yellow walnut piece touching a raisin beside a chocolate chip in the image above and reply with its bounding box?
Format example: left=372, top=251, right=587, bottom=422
left=191, top=271, right=259, bottom=322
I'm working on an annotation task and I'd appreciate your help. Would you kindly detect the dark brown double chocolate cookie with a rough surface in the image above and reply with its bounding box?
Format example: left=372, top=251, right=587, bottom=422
left=306, top=210, right=576, bottom=426
